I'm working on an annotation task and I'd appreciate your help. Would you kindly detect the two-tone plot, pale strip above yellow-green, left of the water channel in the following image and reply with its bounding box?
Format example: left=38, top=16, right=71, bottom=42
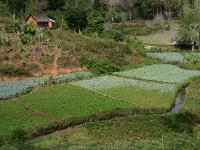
left=72, top=76, right=177, bottom=109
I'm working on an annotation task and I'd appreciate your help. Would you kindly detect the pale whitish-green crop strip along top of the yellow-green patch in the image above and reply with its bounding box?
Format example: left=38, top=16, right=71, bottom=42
left=72, top=76, right=176, bottom=92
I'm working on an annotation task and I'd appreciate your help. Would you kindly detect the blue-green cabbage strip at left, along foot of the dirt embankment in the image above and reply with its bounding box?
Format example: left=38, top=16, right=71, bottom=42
left=0, top=72, right=92, bottom=99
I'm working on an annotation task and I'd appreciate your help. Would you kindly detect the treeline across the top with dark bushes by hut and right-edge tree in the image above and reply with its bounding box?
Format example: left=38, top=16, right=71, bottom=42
left=0, top=0, right=200, bottom=47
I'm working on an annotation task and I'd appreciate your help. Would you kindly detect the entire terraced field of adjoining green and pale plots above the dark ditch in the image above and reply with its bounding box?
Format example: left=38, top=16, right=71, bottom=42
left=0, top=64, right=200, bottom=138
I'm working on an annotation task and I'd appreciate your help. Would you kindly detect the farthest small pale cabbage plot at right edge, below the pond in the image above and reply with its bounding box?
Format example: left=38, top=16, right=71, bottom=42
left=147, top=52, right=200, bottom=63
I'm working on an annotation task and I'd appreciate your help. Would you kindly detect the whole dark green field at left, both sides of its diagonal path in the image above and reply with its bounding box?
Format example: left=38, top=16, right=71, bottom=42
left=0, top=85, right=134, bottom=135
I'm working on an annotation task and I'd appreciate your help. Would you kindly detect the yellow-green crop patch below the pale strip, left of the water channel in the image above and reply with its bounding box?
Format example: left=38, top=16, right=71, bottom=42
left=96, top=86, right=176, bottom=109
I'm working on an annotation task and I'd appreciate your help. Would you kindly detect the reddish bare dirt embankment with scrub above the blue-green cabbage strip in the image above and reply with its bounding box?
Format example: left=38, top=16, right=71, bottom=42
left=0, top=47, right=87, bottom=81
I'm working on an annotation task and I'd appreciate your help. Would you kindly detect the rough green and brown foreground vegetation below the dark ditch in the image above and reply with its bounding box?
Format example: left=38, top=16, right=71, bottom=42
left=30, top=115, right=200, bottom=150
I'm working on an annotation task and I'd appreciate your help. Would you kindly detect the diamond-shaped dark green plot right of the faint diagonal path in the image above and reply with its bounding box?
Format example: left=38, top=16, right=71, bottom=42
left=17, top=85, right=134, bottom=119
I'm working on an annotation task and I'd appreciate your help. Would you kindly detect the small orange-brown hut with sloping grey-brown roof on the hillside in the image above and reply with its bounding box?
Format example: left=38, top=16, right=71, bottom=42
left=25, top=14, right=55, bottom=28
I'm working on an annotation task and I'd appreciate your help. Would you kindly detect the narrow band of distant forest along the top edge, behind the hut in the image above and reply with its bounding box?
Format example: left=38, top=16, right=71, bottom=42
left=0, top=0, right=197, bottom=21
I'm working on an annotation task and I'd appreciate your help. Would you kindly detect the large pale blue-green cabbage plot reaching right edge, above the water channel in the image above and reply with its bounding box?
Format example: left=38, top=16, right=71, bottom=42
left=114, top=64, right=200, bottom=84
